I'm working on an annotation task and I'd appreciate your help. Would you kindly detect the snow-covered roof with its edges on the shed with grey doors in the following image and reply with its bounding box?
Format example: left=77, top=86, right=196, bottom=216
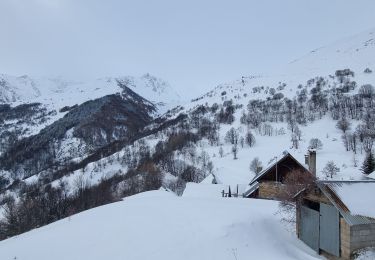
left=318, top=181, right=375, bottom=224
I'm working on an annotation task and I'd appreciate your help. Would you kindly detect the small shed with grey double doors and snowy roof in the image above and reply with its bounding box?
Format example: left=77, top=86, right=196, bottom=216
left=296, top=181, right=375, bottom=259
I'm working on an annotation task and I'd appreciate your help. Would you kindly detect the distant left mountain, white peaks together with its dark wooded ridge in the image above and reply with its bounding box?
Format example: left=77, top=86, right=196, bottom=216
left=0, top=74, right=181, bottom=179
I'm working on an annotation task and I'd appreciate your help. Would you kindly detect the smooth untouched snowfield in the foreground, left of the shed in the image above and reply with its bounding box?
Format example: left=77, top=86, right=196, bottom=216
left=0, top=191, right=319, bottom=260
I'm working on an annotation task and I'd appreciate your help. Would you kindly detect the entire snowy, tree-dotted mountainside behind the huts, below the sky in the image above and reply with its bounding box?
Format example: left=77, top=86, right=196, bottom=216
left=0, top=26, right=375, bottom=256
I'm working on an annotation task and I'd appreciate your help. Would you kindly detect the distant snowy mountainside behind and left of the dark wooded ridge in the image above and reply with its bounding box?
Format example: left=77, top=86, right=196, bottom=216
left=0, top=74, right=181, bottom=160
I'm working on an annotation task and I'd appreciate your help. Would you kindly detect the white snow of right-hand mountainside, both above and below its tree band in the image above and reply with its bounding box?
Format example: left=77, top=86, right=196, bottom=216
left=160, top=28, right=375, bottom=185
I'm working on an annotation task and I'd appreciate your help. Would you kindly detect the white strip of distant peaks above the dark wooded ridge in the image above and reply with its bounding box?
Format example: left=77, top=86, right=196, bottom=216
left=0, top=74, right=182, bottom=113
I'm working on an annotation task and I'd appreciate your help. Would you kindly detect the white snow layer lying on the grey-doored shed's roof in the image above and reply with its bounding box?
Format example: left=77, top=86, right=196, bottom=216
left=329, top=182, right=375, bottom=218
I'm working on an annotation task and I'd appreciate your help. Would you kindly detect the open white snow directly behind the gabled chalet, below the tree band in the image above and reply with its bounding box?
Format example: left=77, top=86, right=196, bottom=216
left=209, top=114, right=365, bottom=185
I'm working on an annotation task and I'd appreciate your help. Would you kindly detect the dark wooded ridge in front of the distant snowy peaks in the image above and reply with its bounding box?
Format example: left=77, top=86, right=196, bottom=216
left=0, top=86, right=156, bottom=178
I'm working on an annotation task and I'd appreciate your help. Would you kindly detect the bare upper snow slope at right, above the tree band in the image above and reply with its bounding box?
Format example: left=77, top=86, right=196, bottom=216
left=185, top=28, right=375, bottom=108
